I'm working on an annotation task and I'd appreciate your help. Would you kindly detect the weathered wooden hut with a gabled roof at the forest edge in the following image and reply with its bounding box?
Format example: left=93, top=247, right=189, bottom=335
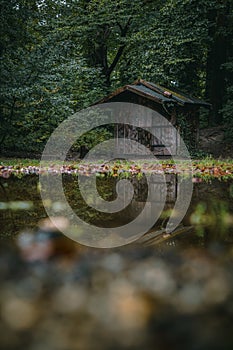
left=97, top=79, right=211, bottom=155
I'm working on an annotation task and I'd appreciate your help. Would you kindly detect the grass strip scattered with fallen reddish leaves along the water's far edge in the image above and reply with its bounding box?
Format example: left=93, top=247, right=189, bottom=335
left=0, top=157, right=233, bottom=181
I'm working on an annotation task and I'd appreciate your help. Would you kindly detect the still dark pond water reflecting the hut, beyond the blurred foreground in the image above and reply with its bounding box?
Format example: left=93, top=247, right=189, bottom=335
left=0, top=174, right=233, bottom=247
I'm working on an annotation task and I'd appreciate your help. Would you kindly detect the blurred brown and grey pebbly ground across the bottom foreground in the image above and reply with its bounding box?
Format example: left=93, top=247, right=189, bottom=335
left=0, top=231, right=233, bottom=350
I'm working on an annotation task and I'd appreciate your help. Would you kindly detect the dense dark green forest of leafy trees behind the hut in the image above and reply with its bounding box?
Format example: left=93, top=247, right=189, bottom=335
left=0, top=0, right=233, bottom=154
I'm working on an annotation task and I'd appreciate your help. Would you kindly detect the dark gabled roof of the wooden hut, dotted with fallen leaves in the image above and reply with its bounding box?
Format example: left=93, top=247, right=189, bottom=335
left=97, top=79, right=211, bottom=108
